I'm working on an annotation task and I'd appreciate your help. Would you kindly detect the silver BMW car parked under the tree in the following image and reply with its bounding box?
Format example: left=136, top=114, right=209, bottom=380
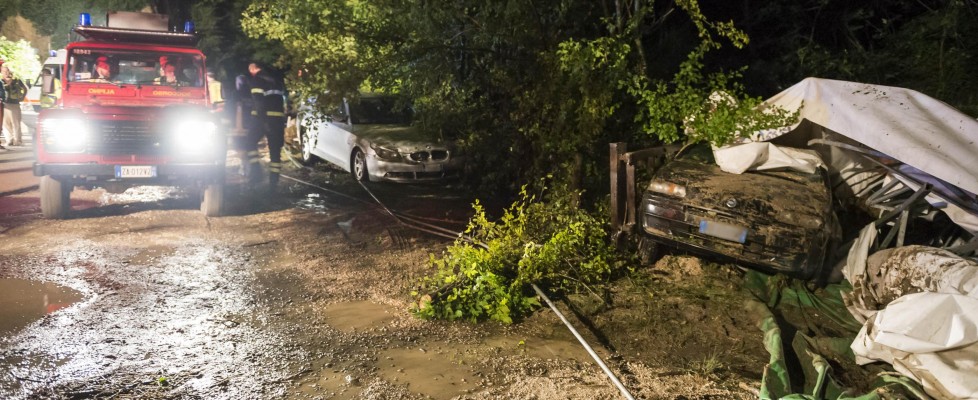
left=298, top=95, right=462, bottom=182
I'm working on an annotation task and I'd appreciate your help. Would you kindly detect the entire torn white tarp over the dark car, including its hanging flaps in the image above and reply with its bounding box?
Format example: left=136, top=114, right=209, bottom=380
left=714, top=78, right=978, bottom=232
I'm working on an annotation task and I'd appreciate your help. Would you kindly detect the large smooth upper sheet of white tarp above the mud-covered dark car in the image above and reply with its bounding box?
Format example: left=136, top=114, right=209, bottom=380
left=755, top=78, right=978, bottom=193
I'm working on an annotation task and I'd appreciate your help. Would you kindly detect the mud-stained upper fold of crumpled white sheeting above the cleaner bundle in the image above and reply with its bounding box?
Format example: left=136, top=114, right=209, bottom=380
left=842, top=224, right=978, bottom=323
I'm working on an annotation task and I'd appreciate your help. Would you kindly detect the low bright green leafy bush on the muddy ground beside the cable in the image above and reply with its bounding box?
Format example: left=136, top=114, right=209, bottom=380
left=411, top=186, right=619, bottom=324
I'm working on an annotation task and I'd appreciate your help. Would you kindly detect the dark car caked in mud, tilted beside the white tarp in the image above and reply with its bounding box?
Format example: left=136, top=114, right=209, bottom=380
left=640, top=146, right=839, bottom=278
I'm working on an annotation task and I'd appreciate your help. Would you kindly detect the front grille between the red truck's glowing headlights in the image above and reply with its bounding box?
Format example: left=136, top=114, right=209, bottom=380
left=88, top=121, right=163, bottom=155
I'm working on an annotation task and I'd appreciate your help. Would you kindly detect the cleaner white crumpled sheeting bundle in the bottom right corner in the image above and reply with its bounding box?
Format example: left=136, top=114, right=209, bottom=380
left=851, top=292, right=978, bottom=400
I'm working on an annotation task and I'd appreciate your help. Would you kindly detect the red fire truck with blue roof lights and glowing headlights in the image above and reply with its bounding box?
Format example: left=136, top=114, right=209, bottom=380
left=34, top=12, right=227, bottom=218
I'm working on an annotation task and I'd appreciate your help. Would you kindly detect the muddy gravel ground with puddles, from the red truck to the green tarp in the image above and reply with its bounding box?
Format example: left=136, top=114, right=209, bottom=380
left=0, top=159, right=808, bottom=399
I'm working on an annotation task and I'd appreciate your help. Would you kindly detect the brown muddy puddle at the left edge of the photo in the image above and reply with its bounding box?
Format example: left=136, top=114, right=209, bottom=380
left=0, top=279, right=82, bottom=336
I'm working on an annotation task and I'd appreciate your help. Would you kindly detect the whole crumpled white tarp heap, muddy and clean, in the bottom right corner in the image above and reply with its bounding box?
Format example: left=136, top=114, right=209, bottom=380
left=843, top=228, right=978, bottom=400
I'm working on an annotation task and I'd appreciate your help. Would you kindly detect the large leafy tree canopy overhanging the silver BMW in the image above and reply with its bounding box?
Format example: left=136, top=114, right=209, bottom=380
left=242, top=0, right=800, bottom=200
